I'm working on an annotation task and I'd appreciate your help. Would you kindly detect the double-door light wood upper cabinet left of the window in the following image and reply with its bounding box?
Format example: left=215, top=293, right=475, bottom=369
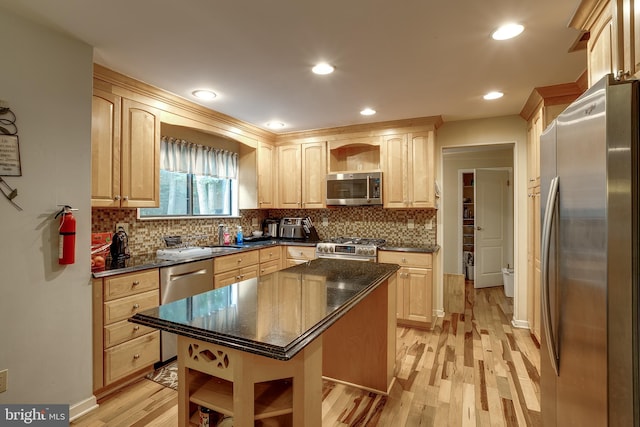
left=91, top=89, right=160, bottom=208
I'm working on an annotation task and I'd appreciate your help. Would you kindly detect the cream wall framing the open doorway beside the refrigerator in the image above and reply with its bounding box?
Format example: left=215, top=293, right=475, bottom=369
left=435, top=116, right=527, bottom=326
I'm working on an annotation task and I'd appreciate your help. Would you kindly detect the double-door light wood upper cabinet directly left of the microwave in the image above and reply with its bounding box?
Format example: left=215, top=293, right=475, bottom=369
left=277, top=142, right=327, bottom=209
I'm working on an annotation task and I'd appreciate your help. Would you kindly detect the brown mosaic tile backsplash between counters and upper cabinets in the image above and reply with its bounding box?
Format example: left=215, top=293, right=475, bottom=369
left=91, top=206, right=437, bottom=254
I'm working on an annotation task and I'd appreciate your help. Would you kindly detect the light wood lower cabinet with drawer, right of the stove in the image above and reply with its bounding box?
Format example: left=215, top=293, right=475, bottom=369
left=378, top=251, right=433, bottom=328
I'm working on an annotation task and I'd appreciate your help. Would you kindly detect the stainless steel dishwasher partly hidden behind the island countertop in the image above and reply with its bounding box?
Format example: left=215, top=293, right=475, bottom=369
left=160, top=259, right=213, bottom=362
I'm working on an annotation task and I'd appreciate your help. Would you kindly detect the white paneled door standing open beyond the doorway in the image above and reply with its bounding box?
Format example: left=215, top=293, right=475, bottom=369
left=474, top=169, right=509, bottom=288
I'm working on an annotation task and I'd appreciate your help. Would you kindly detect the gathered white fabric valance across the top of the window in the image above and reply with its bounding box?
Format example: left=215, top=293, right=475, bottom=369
left=160, top=136, right=238, bottom=179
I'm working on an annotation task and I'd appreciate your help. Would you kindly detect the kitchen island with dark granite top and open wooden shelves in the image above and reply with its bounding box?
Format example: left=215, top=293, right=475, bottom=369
left=131, top=259, right=398, bottom=426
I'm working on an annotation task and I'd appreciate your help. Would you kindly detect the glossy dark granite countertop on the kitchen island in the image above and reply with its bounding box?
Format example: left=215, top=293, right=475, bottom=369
left=129, top=259, right=399, bottom=360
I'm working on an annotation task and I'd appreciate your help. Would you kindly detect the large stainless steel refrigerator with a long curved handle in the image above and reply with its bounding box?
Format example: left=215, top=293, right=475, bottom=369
left=540, top=76, right=640, bottom=427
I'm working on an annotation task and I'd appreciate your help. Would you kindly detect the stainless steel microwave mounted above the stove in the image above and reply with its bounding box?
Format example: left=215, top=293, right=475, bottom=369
left=327, top=172, right=382, bottom=206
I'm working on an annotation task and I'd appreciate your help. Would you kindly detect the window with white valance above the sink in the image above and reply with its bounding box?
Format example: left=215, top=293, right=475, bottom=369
left=138, top=137, right=238, bottom=218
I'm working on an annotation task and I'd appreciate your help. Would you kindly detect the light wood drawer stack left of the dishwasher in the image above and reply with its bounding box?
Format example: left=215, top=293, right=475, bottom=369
left=93, top=268, right=160, bottom=399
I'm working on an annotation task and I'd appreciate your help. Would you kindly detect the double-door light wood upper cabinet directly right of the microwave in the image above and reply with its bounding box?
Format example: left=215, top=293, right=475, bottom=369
left=382, top=131, right=435, bottom=209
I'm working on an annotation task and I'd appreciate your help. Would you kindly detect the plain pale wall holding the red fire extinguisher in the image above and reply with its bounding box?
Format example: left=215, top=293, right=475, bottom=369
left=0, top=8, right=95, bottom=414
